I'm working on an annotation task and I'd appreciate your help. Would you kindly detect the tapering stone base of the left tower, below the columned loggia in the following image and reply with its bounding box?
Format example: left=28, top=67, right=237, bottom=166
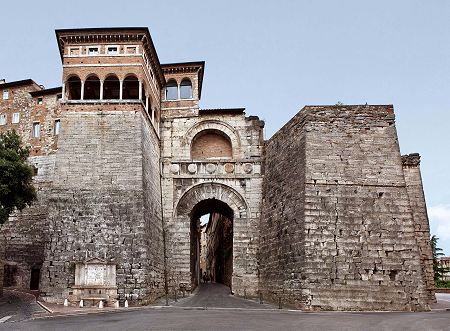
left=35, top=105, right=162, bottom=302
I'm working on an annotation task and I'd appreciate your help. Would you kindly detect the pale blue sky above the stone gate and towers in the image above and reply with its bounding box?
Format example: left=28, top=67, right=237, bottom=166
left=0, top=0, right=450, bottom=256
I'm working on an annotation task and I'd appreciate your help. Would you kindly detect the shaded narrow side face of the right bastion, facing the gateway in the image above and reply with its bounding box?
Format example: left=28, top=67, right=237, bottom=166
left=259, top=109, right=308, bottom=308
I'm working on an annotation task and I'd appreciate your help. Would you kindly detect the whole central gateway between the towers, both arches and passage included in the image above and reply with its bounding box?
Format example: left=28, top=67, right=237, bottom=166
left=161, top=107, right=264, bottom=296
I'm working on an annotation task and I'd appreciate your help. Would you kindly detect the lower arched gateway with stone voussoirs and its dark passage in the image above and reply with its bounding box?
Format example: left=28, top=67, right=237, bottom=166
left=172, top=182, right=256, bottom=292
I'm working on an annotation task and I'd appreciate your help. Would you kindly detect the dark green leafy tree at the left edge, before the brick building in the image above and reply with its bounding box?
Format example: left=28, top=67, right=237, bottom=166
left=0, top=130, right=36, bottom=224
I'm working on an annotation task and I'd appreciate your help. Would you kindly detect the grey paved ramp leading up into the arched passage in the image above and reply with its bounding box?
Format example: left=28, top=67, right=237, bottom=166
left=173, top=283, right=276, bottom=309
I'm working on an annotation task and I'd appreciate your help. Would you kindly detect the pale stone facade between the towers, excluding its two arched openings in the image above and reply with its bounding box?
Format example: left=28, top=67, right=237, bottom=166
left=161, top=107, right=263, bottom=296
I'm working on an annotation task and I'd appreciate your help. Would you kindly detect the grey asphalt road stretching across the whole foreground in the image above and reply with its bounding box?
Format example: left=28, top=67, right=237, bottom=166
left=0, top=308, right=450, bottom=331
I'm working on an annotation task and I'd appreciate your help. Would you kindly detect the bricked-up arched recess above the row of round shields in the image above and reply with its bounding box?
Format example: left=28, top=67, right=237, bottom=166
left=191, top=130, right=232, bottom=160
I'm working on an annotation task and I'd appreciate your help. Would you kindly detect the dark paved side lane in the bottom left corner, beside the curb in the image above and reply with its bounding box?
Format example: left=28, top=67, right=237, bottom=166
left=0, top=290, right=44, bottom=323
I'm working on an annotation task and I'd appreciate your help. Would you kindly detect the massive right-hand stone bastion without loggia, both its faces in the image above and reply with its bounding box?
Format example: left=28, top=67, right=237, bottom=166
left=260, top=106, right=429, bottom=310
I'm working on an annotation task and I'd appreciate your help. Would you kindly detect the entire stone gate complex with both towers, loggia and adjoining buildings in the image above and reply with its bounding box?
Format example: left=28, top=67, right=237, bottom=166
left=0, top=28, right=435, bottom=311
